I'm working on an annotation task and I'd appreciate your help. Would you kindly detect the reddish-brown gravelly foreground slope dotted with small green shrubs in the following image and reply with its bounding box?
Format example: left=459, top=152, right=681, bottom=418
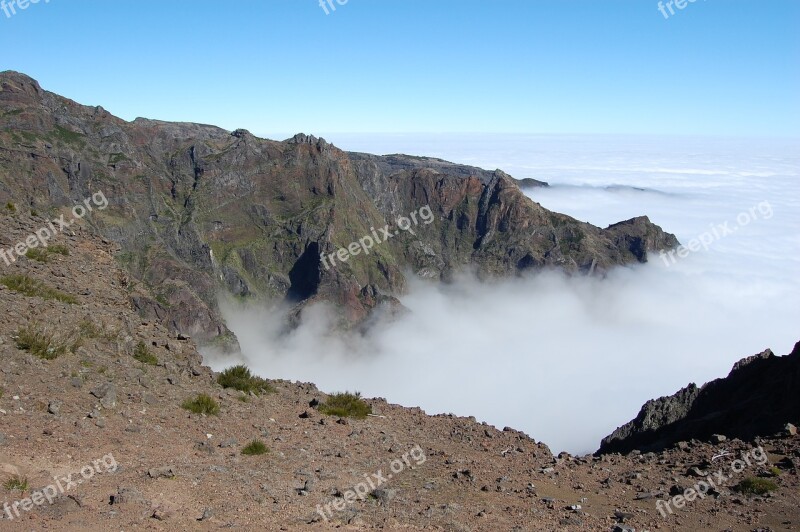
left=0, top=208, right=800, bottom=532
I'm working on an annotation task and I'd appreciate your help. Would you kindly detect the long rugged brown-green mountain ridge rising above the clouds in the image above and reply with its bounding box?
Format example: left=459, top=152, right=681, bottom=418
left=0, top=72, right=677, bottom=343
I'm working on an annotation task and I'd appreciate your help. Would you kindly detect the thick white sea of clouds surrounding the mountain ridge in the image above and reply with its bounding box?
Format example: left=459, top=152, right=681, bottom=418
left=203, top=135, right=800, bottom=453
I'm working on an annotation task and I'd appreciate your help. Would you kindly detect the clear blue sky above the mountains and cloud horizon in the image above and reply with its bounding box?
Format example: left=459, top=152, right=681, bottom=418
left=0, top=0, right=800, bottom=137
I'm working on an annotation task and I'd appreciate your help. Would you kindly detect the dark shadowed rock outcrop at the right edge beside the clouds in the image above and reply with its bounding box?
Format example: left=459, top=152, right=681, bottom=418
left=598, top=343, right=800, bottom=454
